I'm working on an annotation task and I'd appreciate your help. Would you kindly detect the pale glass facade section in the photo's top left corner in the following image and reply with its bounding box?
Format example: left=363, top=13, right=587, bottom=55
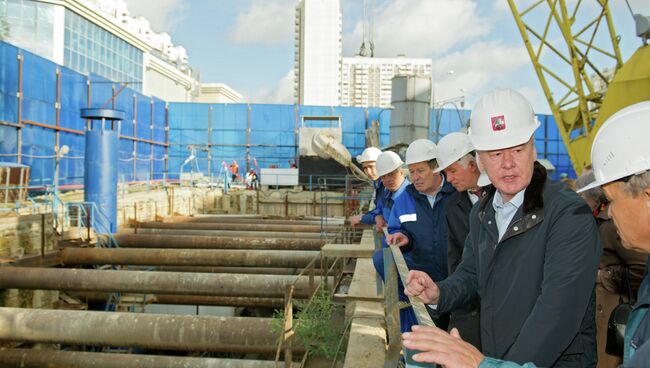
left=0, top=0, right=54, bottom=59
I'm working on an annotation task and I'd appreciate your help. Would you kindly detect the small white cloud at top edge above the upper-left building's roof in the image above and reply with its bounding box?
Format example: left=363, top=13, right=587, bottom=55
left=127, top=0, right=188, bottom=33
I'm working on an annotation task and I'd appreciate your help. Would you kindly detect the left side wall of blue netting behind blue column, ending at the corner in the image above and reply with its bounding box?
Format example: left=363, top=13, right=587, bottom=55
left=0, top=42, right=167, bottom=187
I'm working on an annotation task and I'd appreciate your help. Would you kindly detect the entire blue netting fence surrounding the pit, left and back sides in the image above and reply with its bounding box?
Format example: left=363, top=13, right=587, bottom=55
left=0, top=42, right=575, bottom=190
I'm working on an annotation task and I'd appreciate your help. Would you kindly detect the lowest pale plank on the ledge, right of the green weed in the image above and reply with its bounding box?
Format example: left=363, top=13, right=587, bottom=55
left=343, top=318, right=386, bottom=368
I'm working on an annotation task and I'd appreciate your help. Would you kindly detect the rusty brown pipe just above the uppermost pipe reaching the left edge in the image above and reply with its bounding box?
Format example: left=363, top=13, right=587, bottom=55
left=61, top=247, right=320, bottom=268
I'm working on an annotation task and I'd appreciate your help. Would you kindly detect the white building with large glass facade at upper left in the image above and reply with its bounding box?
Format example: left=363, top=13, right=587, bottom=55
left=0, top=0, right=238, bottom=102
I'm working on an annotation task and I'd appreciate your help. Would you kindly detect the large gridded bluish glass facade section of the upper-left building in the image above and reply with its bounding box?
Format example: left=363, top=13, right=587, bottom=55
left=63, top=9, right=143, bottom=92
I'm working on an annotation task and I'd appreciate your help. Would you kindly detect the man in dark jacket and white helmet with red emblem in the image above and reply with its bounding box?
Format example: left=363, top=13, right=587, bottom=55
left=405, top=90, right=601, bottom=367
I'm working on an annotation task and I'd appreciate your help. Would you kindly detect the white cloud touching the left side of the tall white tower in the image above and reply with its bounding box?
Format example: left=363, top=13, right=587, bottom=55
left=230, top=0, right=295, bottom=44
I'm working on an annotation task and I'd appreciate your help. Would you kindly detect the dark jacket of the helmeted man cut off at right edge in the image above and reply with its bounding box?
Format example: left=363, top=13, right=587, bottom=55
left=623, top=258, right=650, bottom=368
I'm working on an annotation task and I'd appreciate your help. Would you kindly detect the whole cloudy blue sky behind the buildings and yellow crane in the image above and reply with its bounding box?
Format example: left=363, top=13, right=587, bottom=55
left=127, top=0, right=650, bottom=113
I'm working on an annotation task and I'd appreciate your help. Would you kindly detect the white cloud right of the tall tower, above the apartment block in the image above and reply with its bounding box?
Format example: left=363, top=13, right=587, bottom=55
left=344, top=0, right=490, bottom=57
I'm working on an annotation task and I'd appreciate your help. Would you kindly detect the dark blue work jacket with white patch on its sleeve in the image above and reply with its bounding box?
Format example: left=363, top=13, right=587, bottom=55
left=388, top=179, right=456, bottom=281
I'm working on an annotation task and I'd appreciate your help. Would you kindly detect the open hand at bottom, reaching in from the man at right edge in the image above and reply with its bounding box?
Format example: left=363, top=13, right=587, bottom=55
left=402, top=326, right=484, bottom=368
